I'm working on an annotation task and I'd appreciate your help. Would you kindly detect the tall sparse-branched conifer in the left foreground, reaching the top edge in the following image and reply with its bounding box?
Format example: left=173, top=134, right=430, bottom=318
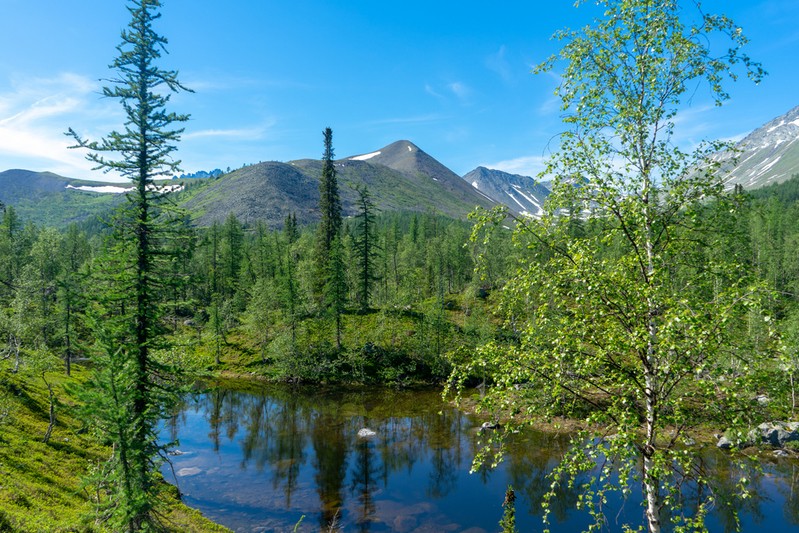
left=68, top=0, right=188, bottom=531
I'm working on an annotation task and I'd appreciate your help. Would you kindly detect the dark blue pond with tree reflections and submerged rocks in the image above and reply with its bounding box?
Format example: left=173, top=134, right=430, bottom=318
left=162, top=385, right=799, bottom=533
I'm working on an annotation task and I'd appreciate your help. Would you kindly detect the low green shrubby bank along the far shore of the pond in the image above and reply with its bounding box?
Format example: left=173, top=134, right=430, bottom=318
left=185, top=296, right=496, bottom=386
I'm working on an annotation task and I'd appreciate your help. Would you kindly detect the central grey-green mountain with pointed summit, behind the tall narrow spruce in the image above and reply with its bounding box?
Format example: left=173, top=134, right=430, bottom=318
left=184, top=141, right=493, bottom=227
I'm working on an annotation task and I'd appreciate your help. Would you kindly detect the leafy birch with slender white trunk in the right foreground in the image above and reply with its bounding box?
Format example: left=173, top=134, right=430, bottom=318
left=454, top=0, right=771, bottom=533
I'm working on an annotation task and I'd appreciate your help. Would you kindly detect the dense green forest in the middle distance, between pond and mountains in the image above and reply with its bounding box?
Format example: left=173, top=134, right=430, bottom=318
left=0, top=174, right=799, bottom=528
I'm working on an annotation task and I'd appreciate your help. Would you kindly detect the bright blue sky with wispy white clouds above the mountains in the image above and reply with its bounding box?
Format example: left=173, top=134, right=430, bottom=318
left=0, top=0, right=799, bottom=180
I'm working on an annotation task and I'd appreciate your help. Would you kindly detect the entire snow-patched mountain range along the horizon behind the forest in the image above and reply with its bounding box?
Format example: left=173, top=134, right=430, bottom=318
left=9, top=107, right=799, bottom=227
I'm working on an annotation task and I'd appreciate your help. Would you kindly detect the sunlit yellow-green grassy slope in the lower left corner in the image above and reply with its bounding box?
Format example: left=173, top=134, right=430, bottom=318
left=0, top=364, right=228, bottom=533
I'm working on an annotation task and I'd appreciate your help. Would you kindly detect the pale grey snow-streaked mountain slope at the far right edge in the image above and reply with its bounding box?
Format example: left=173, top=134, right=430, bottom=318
left=716, top=106, right=799, bottom=189
